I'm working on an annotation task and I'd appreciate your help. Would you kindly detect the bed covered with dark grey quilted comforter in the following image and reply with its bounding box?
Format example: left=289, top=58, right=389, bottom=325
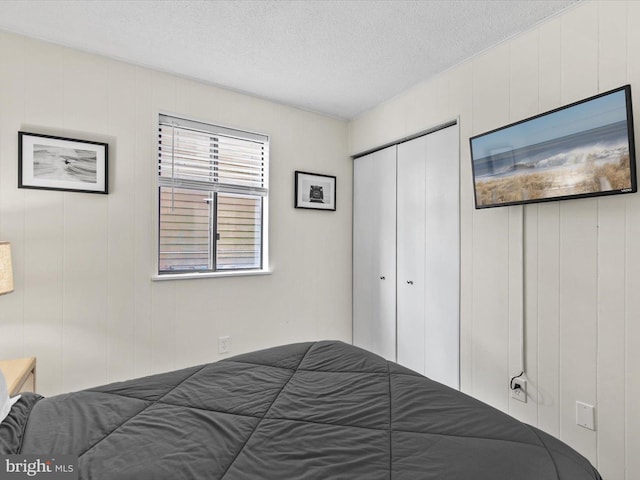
left=0, top=341, right=601, bottom=480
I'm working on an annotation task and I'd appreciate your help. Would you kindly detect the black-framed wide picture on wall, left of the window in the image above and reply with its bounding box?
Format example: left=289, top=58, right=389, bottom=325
left=18, top=132, right=109, bottom=193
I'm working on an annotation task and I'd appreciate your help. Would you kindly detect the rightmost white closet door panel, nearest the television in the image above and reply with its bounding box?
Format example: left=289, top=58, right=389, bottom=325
left=424, top=125, right=460, bottom=389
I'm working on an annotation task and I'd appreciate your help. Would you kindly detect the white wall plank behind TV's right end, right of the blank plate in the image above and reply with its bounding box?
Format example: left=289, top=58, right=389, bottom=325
left=596, top=1, right=628, bottom=478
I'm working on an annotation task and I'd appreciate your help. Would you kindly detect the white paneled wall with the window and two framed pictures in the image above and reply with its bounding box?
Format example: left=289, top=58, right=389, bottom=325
left=0, top=32, right=352, bottom=395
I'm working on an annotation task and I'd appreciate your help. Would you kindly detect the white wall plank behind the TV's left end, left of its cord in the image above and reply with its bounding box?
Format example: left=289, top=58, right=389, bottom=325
left=470, top=44, right=510, bottom=410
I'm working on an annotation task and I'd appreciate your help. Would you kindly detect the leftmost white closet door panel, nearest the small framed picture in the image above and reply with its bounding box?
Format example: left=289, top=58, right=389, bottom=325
left=353, top=146, right=396, bottom=361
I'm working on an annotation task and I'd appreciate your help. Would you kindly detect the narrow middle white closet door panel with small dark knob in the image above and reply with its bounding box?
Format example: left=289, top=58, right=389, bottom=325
left=396, top=137, right=426, bottom=373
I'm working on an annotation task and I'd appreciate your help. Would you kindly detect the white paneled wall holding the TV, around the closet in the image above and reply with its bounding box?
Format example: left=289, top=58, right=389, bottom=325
left=349, top=1, right=640, bottom=480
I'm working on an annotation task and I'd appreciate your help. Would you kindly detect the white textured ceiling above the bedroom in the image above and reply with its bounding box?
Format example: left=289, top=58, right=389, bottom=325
left=0, top=0, right=576, bottom=119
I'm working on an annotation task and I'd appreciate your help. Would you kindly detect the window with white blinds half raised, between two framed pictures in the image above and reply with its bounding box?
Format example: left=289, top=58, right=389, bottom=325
left=158, top=114, right=269, bottom=275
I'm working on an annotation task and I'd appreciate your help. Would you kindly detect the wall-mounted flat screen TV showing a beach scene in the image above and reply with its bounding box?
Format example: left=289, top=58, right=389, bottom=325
left=469, top=85, right=637, bottom=208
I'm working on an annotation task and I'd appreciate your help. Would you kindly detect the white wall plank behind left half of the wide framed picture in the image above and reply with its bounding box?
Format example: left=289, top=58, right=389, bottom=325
left=21, top=42, right=65, bottom=391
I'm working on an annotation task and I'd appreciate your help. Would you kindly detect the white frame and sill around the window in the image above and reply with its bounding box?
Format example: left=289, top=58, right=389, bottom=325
left=151, top=111, right=272, bottom=281
